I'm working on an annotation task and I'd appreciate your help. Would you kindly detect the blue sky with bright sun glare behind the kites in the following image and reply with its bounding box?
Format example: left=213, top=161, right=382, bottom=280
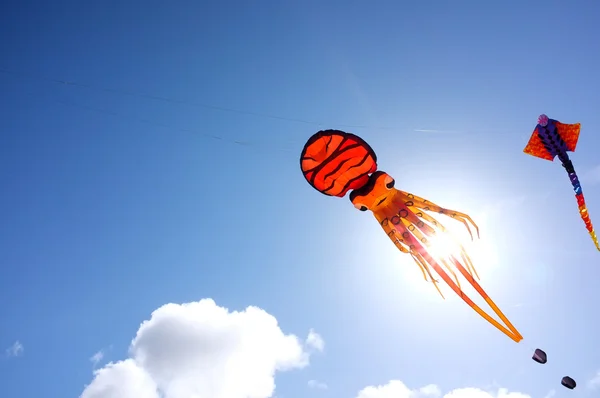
left=0, top=0, right=600, bottom=398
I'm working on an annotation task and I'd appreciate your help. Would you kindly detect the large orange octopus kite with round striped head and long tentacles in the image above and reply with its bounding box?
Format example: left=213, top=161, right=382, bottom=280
left=300, top=130, right=523, bottom=343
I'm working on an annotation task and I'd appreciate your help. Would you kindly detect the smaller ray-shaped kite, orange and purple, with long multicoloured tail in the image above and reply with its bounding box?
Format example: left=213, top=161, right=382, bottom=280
left=523, top=115, right=600, bottom=250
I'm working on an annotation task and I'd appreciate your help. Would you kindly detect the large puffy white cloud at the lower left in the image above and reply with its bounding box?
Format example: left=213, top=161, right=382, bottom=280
left=80, top=299, right=322, bottom=398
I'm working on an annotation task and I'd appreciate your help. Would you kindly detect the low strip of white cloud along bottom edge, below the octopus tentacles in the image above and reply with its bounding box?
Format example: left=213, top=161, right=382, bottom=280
left=356, top=380, right=531, bottom=398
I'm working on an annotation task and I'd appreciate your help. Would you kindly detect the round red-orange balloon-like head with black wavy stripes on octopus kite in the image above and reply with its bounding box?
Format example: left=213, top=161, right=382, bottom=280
left=300, top=130, right=377, bottom=198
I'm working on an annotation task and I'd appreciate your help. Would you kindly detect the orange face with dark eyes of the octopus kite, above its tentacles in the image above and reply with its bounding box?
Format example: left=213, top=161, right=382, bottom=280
left=350, top=171, right=396, bottom=212
